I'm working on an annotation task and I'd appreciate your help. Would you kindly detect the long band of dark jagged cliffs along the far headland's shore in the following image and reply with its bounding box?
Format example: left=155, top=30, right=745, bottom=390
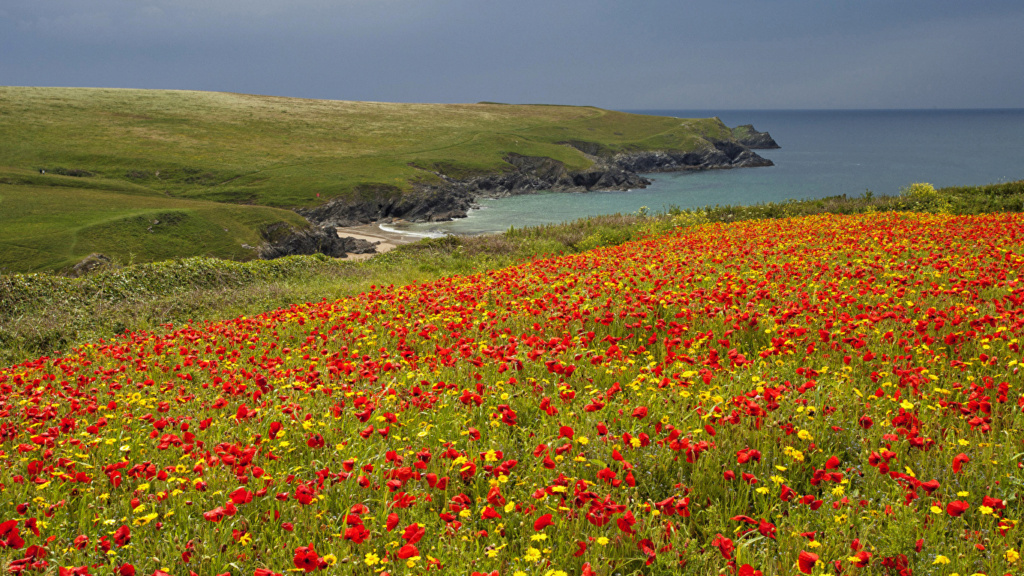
left=298, top=140, right=772, bottom=227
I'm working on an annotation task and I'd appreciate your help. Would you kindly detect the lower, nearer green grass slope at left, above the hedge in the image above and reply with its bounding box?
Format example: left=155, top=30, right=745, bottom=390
left=0, top=184, right=305, bottom=273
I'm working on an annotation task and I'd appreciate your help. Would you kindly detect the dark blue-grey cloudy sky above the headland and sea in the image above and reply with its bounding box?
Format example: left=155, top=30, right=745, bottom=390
left=0, top=0, right=1024, bottom=110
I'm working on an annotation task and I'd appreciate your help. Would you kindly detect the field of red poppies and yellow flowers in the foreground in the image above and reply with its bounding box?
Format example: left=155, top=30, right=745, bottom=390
left=0, top=213, right=1024, bottom=576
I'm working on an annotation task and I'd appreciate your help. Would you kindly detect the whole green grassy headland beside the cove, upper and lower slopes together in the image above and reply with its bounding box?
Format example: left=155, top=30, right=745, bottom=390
left=0, top=87, right=731, bottom=272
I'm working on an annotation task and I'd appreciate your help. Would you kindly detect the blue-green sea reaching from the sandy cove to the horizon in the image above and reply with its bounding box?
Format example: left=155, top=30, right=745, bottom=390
left=387, top=110, right=1024, bottom=236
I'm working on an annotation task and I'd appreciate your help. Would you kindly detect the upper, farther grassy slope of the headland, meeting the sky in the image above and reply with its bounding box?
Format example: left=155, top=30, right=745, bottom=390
left=0, top=87, right=731, bottom=208
